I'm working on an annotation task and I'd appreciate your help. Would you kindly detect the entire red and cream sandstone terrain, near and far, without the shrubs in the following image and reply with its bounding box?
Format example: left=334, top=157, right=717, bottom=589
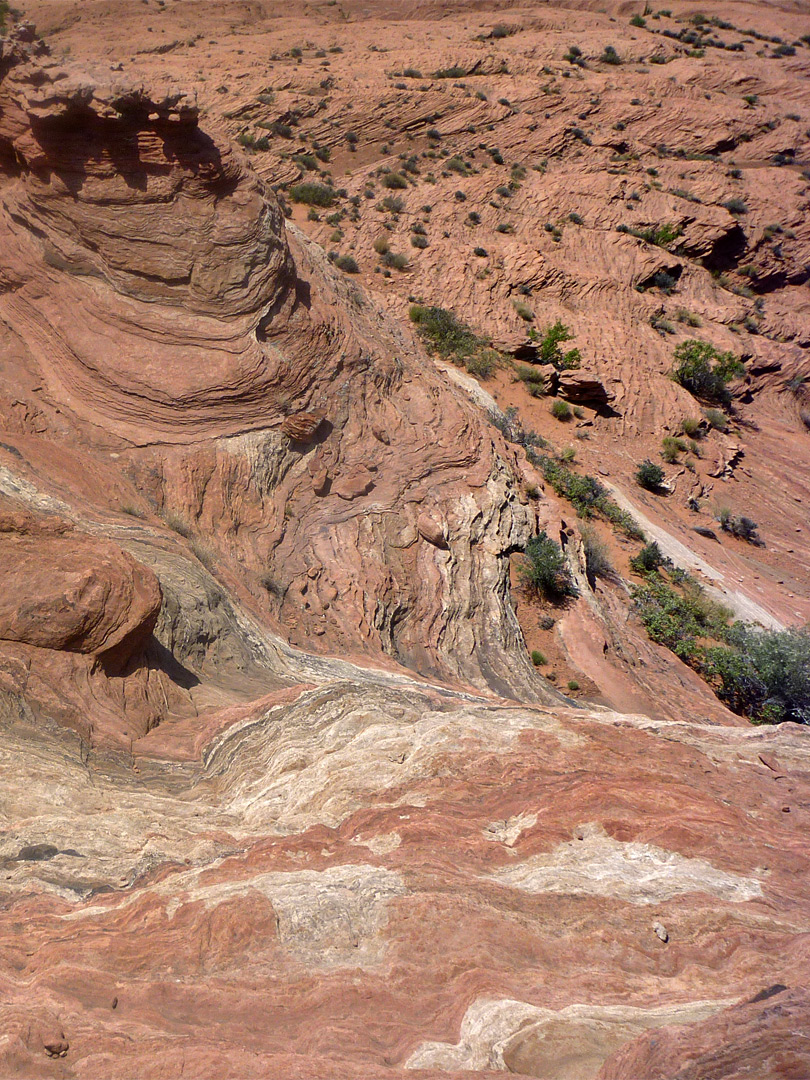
left=0, top=6, right=810, bottom=1080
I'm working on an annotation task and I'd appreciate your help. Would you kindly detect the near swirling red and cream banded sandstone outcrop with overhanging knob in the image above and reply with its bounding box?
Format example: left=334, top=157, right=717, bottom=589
left=0, top=5, right=810, bottom=1080
